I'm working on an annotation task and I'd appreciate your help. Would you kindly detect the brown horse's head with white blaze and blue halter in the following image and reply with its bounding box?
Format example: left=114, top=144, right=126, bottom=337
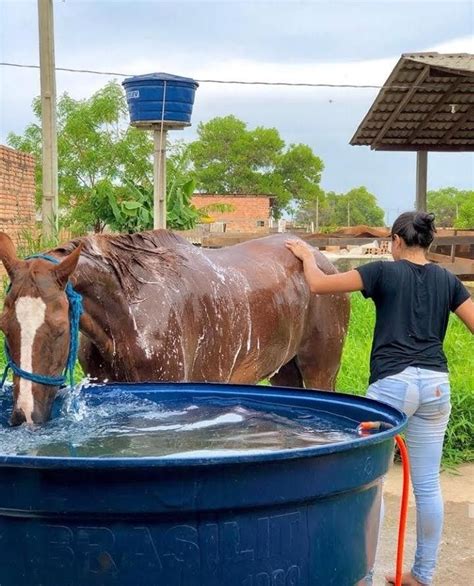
left=0, top=233, right=81, bottom=425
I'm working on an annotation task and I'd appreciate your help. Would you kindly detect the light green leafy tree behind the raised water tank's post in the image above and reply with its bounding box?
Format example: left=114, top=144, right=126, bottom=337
left=8, top=90, right=232, bottom=233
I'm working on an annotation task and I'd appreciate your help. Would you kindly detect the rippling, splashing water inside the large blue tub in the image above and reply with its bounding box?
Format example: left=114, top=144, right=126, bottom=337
left=0, top=381, right=357, bottom=458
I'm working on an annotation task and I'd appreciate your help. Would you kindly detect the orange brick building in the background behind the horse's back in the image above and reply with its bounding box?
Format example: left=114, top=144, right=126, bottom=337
left=192, top=194, right=271, bottom=232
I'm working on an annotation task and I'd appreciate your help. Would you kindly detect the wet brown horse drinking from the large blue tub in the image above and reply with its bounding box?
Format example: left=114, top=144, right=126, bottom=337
left=0, top=231, right=349, bottom=425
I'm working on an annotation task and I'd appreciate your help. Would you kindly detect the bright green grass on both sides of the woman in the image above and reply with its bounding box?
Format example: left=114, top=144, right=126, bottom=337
left=336, top=293, right=474, bottom=466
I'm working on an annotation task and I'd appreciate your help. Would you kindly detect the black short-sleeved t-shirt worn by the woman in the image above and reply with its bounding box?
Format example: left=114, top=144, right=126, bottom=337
left=356, top=260, right=469, bottom=383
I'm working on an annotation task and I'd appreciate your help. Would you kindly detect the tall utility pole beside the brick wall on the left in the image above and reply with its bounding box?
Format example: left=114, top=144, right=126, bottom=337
left=38, top=0, right=58, bottom=239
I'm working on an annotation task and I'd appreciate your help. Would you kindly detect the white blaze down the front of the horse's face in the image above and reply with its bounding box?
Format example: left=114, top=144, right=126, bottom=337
left=15, top=296, right=46, bottom=423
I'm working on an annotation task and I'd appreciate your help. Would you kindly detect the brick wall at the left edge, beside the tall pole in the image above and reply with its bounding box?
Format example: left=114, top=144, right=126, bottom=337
left=0, top=145, right=35, bottom=243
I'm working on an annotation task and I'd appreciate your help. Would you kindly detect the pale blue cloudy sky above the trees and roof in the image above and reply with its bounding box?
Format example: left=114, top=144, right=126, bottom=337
left=0, top=0, right=474, bottom=223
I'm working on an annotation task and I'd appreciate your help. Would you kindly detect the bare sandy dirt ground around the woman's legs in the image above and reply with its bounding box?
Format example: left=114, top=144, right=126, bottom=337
left=374, top=464, right=474, bottom=586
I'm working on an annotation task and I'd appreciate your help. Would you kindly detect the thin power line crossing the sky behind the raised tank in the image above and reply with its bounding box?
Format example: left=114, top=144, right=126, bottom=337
left=0, top=62, right=412, bottom=90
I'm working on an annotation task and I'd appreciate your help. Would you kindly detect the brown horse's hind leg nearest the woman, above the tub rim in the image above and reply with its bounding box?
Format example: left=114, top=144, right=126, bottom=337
left=296, top=295, right=349, bottom=391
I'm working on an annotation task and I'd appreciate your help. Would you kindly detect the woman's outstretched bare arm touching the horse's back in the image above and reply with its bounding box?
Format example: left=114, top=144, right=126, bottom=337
left=286, top=240, right=364, bottom=293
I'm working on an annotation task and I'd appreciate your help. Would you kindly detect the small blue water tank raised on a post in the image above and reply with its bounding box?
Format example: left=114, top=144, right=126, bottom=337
left=122, top=73, right=199, bottom=128
